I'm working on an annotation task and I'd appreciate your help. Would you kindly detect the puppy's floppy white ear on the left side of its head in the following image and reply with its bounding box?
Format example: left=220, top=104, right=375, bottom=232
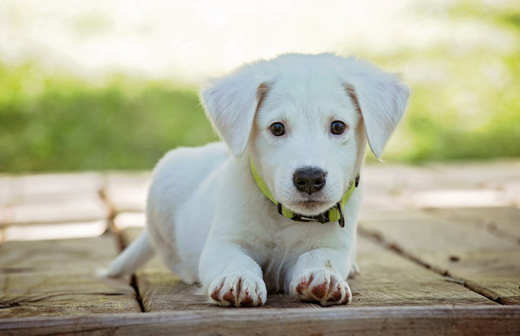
left=200, top=66, right=269, bottom=157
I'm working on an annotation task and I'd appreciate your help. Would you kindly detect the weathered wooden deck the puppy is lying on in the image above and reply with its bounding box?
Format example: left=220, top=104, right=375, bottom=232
left=0, top=161, right=520, bottom=335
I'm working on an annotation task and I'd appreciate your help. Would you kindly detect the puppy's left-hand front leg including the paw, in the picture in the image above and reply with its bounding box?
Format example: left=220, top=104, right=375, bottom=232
left=199, top=241, right=267, bottom=307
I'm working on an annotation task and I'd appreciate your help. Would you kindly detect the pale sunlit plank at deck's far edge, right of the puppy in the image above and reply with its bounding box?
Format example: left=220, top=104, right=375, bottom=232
left=363, top=160, right=520, bottom=209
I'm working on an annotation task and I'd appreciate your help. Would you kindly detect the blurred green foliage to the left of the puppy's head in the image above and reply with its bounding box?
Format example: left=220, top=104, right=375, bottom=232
left=0, top=65, right=216, bottom=172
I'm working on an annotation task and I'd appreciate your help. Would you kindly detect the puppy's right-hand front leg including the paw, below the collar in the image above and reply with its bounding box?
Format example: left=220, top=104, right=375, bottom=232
left=289, top=248, right=352, bottom=306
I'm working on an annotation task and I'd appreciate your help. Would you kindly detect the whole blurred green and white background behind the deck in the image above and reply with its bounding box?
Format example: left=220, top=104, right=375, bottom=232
left=0, top=0, right=520, bottom=173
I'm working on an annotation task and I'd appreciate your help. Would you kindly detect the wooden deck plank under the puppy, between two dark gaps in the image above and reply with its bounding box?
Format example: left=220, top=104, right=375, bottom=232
left=123, top=229, right=495, bottom=312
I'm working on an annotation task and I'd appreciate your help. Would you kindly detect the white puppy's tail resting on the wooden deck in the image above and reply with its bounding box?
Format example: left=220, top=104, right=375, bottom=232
left=101, top=230, right=155, bottom=278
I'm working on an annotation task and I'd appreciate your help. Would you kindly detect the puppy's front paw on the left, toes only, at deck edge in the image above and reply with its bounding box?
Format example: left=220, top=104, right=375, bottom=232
left=209, top=273, right=267, bottom=307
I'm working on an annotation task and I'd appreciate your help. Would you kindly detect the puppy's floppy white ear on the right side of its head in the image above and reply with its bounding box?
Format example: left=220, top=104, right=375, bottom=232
left=344, top=67, right=410, bottom=160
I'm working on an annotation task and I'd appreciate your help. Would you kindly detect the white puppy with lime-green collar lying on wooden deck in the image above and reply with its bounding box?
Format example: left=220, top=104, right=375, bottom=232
left=108, top=54, right=409, bottom=306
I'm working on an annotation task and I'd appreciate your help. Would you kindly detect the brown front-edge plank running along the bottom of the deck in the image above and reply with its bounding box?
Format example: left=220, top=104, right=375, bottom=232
left=0, top=306, right=520, bottom=336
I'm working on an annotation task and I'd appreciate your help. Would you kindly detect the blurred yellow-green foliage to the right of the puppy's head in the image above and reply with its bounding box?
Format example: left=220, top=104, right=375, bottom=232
left=377, top=0, right=520, bottom=162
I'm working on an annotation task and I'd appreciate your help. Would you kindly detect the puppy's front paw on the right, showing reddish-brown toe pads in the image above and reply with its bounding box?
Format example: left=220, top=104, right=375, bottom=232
left=290, top=269, right=352, bottom=306
